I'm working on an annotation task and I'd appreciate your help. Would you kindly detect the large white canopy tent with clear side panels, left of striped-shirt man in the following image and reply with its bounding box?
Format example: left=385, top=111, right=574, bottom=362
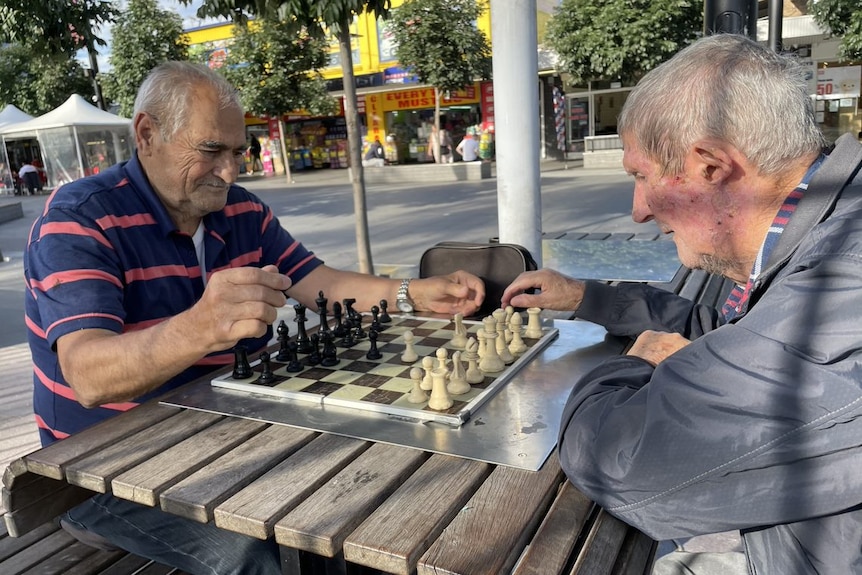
left=0, top=94, right=133, bottom=187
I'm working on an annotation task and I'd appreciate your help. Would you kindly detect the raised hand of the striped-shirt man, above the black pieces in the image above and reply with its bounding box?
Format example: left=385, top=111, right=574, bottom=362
left=187, top=265, right=290, bottom=352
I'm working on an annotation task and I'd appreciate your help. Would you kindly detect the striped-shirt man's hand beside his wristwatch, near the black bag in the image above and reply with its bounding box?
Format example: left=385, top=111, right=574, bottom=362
left=409, top=270, right=485, bottom=316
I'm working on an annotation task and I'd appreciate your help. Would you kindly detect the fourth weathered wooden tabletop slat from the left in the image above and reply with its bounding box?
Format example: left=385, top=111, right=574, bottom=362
left=159, top=425, right=318, bottom=523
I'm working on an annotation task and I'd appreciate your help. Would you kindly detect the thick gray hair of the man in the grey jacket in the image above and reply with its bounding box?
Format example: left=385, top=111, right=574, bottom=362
left=617, top=34, right=826, bottom=175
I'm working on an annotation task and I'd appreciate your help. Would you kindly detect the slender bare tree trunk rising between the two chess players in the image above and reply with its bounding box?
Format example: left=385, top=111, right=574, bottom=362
left=338, top=17, right=374, bottom=274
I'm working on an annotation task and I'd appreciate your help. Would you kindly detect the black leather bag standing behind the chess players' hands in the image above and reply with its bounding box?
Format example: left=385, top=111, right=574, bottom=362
left=419, top=242, right=538, bottom=318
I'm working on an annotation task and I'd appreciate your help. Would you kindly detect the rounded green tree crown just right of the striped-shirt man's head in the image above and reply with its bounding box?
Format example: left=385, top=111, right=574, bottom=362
left=220, top=19, right=335, bottom=116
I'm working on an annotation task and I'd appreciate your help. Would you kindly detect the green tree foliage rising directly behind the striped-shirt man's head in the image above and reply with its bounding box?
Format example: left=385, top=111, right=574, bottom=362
left=100, top=0, right=188, bottom=118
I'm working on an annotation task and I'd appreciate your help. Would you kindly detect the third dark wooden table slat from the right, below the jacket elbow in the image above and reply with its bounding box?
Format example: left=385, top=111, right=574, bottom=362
left=512, top=481, right=595, bottom=575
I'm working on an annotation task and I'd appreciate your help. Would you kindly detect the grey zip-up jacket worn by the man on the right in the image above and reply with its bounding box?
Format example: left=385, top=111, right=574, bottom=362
left=559, top=136, right=862, bottom=575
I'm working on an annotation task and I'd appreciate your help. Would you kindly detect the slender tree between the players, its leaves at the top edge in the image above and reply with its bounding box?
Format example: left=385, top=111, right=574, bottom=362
left=186, top=0, right=391, bottom=273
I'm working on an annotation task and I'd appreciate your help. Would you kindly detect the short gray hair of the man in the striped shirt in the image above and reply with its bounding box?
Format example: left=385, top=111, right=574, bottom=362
left=132, top=62, right=242, bottom=142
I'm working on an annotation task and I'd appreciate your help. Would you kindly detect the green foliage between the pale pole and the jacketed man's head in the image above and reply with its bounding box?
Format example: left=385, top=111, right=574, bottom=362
left=545, top=0, right=703, bottom=84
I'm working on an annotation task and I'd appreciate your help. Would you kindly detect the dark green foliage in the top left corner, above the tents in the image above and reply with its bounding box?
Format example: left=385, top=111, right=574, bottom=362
left=0, top=0, right=118, bottom=54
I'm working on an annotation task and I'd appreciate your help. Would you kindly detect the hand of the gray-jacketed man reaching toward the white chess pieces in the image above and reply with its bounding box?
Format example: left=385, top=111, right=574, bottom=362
left=500, top=268, right=584, bottom=311
